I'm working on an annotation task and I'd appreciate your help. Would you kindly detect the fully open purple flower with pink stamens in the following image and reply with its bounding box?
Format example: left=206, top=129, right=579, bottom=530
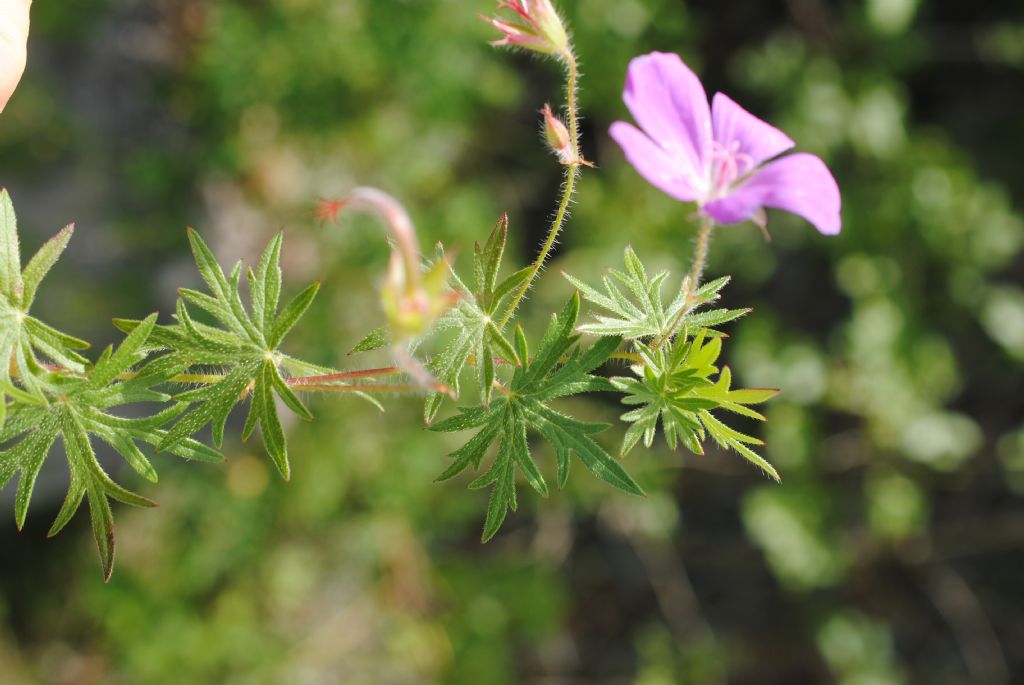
left=610, top=52, right=842, bottom=236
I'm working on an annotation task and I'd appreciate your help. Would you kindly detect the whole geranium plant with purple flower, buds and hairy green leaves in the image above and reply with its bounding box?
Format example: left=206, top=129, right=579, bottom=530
left=0, top=0, right=840, bottom=577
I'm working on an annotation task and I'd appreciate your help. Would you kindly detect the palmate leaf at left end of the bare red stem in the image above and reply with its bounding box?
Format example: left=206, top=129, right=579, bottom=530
left=115, top=229, right=317, bottom=480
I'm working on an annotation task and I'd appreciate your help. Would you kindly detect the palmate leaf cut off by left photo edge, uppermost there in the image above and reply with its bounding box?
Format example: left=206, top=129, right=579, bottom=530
left=0, top=189, right=89, bottom=417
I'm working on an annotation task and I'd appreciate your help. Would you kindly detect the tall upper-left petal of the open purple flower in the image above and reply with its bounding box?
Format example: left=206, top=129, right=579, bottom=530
left=623, top=52, right=712, bottom=183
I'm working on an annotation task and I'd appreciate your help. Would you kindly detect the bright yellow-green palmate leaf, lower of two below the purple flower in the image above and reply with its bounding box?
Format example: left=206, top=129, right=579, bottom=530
left=610, top=329, right=779, bottom=480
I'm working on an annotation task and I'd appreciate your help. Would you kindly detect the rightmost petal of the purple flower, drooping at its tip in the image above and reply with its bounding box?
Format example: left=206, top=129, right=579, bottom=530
left=703, top=153, right=842, bottom=236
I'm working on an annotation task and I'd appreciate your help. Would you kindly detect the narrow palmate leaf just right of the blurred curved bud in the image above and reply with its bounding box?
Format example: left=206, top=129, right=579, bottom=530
left=423, top=216, right=529, bottom=424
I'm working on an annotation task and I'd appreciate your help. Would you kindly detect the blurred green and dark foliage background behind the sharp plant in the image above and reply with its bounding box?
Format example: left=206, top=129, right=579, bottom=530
left=0, top=0, right=1024, bottom=685
